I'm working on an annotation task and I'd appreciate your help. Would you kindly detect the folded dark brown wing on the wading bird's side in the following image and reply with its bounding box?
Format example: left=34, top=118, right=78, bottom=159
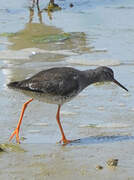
left=18, top=67, right=79, bottom=96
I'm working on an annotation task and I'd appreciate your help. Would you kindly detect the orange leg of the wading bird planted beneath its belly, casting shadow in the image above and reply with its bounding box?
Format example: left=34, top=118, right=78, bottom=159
left=56, top=105, right=72, bottom=144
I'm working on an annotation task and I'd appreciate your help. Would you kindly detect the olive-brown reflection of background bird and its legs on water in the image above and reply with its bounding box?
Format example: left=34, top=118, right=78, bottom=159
left=8, top=4, right=88, bottom=53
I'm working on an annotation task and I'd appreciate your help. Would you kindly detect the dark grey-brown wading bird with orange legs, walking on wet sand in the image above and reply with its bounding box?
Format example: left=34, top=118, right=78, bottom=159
left=8, top=66, right=128, bottom=144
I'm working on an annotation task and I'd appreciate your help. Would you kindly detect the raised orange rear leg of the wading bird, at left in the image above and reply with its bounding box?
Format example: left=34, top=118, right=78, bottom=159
left=9, top=99, right=33, bottom=143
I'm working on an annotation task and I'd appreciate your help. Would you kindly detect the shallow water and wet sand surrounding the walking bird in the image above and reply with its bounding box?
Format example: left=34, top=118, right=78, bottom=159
left=0, top=0, right=134, bottom=180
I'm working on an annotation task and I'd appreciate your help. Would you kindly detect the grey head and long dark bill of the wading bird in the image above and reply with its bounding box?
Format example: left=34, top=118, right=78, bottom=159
left=95, top=66, right=128, bottom=91
